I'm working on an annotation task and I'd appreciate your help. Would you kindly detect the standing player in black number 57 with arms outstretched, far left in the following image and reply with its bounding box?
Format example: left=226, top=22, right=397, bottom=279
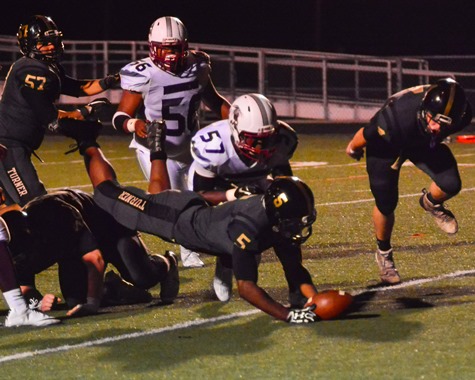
left=0, top=15, right=118, bottom=206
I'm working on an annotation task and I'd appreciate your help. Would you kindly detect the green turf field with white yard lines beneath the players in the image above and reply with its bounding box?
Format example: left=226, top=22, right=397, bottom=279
left=0, top=135, right=475, bottom=379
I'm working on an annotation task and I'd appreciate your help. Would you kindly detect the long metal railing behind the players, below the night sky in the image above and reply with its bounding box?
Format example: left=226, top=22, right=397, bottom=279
left=0, top=36, right=475, bottom=120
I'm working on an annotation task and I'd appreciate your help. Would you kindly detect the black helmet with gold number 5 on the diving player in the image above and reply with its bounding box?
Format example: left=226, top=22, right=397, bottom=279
left=264, top=177, right=317, bottom=244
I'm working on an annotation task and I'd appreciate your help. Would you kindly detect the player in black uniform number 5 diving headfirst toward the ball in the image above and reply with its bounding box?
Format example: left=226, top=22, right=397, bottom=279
left=70, top=121, right=318, bottom=323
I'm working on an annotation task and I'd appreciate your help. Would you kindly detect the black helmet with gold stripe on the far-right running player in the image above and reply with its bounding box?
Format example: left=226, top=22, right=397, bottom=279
left=419, top=78, right=468, bottom=133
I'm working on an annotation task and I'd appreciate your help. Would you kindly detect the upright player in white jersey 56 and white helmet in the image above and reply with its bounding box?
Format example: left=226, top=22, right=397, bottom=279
left=113, top=17, right=229, bottom=268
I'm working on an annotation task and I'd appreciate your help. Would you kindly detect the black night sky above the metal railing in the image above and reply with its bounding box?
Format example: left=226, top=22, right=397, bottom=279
left=0, top=0, right=475, bottom=56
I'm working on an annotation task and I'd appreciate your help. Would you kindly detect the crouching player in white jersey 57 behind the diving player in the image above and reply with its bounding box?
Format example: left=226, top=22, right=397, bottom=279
left=188, top=94, right=298, bottom=302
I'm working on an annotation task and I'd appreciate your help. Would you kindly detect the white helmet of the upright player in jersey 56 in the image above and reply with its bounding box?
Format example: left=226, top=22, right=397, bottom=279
left=148, top=16, right=188, bottom=74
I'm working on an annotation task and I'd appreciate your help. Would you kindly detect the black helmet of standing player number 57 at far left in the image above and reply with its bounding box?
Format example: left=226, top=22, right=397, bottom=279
left=17, top=15, right=64, bottom=62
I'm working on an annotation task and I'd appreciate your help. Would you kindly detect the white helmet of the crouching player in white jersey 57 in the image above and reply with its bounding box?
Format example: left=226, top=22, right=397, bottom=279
left=229, top=94, right=278, bottom=165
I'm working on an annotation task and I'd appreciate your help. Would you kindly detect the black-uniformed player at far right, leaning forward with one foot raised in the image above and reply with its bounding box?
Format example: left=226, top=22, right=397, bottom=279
left=346, top=78, right=472, bottom=284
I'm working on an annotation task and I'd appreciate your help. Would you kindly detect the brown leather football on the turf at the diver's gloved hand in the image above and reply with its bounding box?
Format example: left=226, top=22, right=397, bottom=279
left=305, top=290, right=353, bottom=320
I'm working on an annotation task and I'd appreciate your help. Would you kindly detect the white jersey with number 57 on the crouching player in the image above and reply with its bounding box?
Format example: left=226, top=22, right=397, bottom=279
left=188, top=120, right=298, bottom=188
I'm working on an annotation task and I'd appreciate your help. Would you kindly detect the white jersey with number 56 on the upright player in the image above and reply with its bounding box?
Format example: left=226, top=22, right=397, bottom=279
left=120, top=52, right=210, bottom=162
